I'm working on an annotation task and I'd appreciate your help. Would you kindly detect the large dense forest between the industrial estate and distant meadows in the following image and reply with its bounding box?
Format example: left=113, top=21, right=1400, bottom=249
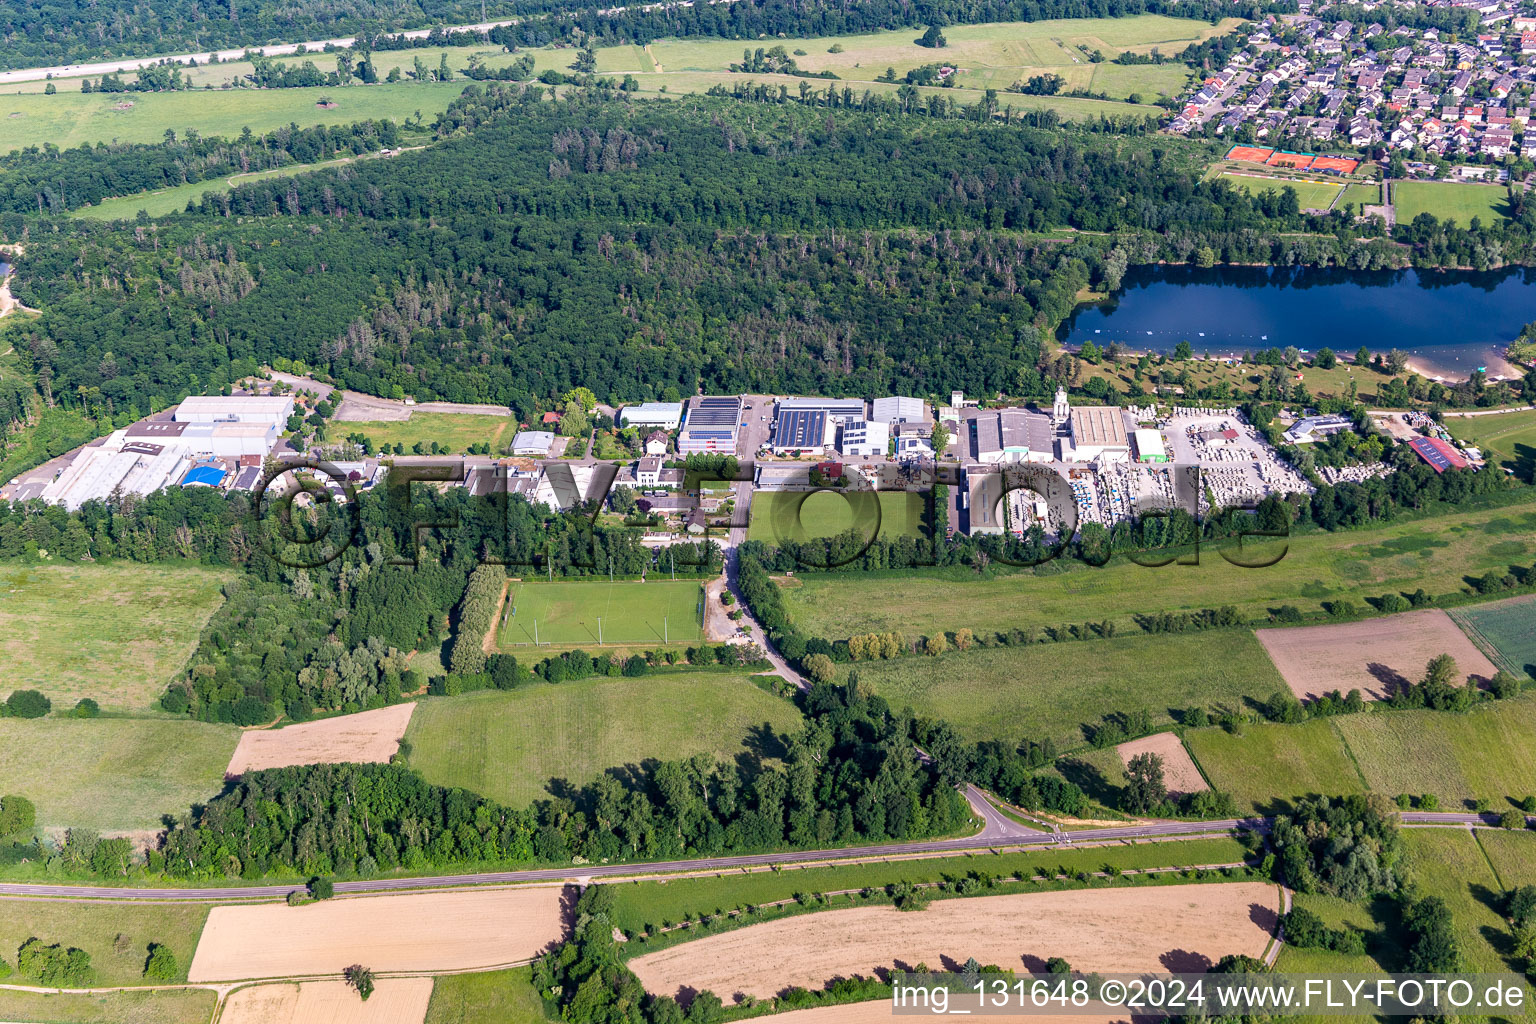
left=0, top=83, right=1402, bottom=423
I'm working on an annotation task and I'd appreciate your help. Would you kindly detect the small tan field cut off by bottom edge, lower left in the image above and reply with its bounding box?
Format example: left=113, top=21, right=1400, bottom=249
left=218, top=978, right=432, bottom=1024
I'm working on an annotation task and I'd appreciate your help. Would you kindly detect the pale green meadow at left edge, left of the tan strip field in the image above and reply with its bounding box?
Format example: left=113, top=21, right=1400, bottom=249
left=0, top=718, right=238, bottom=831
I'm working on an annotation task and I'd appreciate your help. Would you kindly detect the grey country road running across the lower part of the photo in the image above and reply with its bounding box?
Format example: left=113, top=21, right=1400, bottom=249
left=0, top=810, right=1505, bottom=903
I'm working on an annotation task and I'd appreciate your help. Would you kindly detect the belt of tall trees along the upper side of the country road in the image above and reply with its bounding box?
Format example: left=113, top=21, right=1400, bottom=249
left=158, top=688, right=971, bottom=878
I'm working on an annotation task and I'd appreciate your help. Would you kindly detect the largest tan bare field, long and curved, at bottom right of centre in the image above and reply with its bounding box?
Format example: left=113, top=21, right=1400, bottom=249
left=630, top=881, right=1279, bottom=1004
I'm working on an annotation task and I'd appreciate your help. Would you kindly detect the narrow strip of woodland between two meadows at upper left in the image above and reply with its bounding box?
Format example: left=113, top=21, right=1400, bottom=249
left=0, top=120, right=401, bottom=214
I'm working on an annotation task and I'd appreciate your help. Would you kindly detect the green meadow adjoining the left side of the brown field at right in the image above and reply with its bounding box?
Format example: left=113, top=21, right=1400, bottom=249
left=859, top=631, right=1284, bottom=751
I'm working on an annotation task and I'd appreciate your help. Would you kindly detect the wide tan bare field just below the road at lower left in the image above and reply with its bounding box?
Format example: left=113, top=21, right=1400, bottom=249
left=187, top=886, right=565, bottom=981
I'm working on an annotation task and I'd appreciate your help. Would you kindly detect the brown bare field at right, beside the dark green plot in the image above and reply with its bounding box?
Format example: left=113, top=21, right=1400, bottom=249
left=1253, top=608, right=1496, bottom=700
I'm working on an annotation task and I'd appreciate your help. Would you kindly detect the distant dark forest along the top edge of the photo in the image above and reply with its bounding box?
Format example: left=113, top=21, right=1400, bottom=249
left=0, top=0, right=1277, bottom=69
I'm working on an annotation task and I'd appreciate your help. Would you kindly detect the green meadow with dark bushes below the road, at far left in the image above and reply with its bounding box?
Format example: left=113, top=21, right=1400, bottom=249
left=0, top=900, right=207, bottom=987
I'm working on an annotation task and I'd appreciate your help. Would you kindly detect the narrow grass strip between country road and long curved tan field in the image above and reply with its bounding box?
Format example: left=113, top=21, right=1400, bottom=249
left=602, top=838, right=1246, bottom=939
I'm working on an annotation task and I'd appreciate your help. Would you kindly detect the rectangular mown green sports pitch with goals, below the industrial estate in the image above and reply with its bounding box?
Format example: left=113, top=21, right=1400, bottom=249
left=496, top=579, right=703, bottom=654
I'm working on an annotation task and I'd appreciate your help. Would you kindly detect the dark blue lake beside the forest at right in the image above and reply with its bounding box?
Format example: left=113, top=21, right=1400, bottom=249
left=1060, top=266, right=1536, bottom=378
